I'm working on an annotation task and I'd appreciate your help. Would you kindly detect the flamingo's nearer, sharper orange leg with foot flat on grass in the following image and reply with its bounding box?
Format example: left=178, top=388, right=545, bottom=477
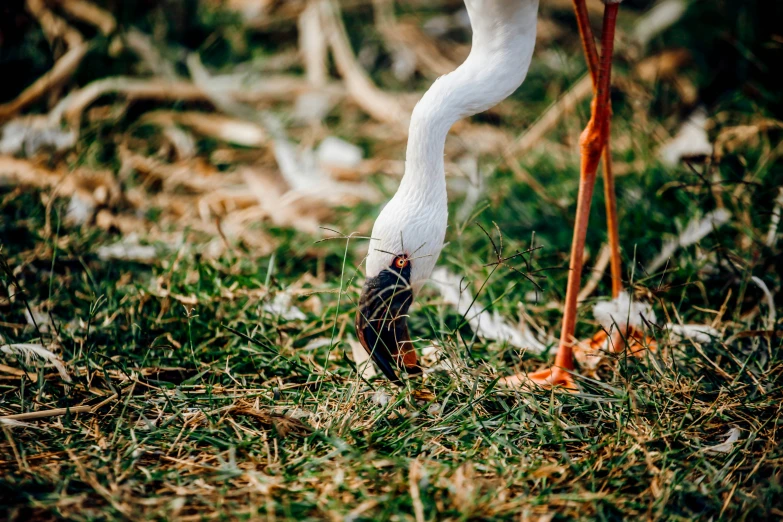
left=502, top=0, right=619, bottom=389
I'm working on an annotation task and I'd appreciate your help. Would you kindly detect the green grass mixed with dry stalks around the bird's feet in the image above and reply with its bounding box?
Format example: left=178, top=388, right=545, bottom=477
left=0, top=0, right=783, bottom=520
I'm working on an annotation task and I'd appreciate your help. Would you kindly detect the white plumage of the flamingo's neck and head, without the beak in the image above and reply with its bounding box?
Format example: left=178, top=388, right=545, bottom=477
left=367, top=0, right=538, bottom=292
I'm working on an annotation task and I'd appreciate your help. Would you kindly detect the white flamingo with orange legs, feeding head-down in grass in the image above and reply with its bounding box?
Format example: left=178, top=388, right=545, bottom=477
left=356, top=0, right=622, bottom=389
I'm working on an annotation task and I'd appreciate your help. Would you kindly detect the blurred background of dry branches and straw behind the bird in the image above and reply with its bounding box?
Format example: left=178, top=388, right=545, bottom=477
left=0, top=0, right=783, bottom=324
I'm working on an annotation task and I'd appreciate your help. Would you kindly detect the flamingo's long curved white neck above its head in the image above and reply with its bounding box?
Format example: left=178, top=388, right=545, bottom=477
left=399, top=0, right=538, bottom=201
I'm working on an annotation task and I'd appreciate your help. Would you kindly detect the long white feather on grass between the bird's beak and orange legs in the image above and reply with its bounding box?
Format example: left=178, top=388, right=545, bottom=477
left=432, top=267, right=547, bottom=353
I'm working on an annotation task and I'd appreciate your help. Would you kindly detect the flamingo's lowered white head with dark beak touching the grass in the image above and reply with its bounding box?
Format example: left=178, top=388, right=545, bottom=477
left=356, top=183, right=448, bottom=384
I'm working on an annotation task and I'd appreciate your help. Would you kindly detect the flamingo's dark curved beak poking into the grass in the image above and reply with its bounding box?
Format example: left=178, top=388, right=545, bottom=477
left=356, top=271, right=421, bottom=385
